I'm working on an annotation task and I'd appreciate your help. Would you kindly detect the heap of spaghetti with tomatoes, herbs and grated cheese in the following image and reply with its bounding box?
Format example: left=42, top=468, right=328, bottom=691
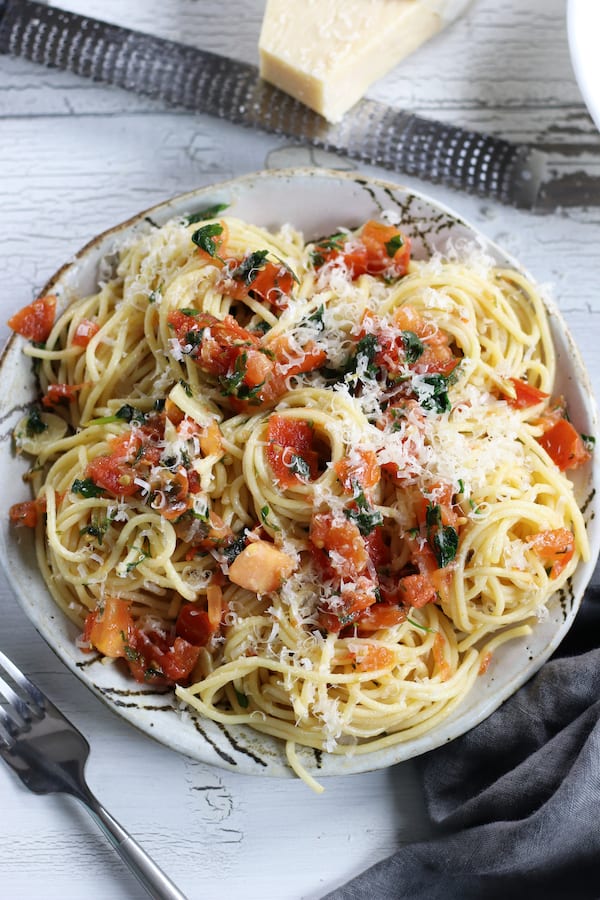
left=13, top=216, right=588, bottom=781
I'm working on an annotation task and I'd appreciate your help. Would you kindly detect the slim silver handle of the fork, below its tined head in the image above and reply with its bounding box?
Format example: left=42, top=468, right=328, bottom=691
left=79, top=793, right=187, bottom=900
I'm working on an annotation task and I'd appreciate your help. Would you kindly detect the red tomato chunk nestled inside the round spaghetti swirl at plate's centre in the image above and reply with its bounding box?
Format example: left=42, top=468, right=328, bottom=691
left=266, top=415, right=319, bottom=488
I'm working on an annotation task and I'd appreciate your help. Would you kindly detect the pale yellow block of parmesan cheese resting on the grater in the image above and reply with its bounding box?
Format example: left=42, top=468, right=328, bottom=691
left=259, top=0, right=470, bottom=122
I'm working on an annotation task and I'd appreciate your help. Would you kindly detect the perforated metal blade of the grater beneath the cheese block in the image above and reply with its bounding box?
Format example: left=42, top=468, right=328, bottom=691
left=0, top=0, right=546, bottom=208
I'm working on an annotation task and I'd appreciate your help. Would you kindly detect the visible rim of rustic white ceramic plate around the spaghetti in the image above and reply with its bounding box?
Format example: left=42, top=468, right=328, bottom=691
left=0, top=169, right=600, bottom=775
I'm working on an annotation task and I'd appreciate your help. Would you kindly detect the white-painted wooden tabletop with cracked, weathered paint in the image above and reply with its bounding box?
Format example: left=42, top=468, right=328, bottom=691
left=0, top=0, right=600, bottom=900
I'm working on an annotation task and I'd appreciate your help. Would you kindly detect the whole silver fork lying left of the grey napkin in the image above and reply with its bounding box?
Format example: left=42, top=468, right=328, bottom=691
left=0, top=650, right=186, bottom=900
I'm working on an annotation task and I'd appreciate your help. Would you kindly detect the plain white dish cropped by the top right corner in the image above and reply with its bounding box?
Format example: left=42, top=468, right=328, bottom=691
left=567, top=0, right=600, bottom=130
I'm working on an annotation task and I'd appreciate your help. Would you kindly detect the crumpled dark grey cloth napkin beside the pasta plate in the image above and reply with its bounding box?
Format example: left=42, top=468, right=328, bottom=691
left=324, top=570, right=600, bottom=900
